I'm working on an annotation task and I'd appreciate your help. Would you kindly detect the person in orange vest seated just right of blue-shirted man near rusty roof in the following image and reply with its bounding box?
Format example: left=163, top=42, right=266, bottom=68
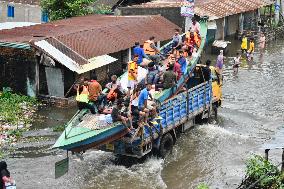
left=143, top=36, right=161, bottom=64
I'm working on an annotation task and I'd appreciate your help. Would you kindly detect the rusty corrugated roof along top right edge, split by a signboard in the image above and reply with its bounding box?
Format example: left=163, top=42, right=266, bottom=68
left=128, top=0, right=274, bottom=19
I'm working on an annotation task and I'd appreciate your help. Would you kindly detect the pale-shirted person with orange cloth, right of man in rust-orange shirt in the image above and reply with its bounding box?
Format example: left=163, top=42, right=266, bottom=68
left=106, top=75, right=124, bottom=102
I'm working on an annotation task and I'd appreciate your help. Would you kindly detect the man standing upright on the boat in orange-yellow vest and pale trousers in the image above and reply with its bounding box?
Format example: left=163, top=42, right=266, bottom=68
left=127, top=54, right=139, bottom=96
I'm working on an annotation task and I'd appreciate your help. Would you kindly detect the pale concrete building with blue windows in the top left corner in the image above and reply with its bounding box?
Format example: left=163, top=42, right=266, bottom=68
left=0, top=0, right=48, bottom=23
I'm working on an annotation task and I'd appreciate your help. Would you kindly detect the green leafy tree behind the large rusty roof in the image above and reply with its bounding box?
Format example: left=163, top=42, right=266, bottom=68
left=40, top=0, right=96, bottom=20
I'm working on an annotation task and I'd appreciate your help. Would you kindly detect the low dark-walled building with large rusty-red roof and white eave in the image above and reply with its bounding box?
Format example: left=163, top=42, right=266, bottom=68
left=0, top=15, right=178, bottom=106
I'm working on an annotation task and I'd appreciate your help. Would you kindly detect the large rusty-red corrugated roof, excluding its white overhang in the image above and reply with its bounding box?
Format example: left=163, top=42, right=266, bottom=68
left=0, top=15, right=179, bottom=65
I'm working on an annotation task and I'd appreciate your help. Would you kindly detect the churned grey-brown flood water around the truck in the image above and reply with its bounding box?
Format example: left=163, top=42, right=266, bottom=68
left=4, top=36, right=284, bottom=189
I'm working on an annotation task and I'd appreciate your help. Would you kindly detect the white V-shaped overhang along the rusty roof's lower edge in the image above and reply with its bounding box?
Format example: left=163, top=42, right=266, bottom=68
left=34, top=40, right=117, bottom=74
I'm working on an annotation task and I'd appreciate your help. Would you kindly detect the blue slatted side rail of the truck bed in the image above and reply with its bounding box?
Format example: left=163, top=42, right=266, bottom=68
left=143, top=81, right=212, bottom=141
